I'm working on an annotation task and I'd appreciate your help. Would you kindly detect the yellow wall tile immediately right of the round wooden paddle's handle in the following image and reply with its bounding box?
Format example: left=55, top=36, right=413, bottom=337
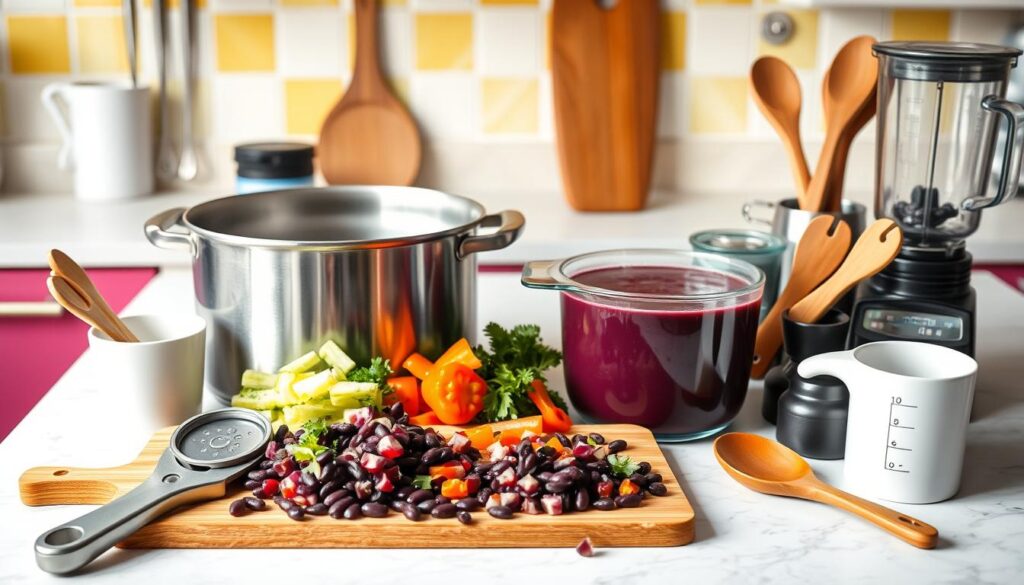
left=416, top=12, right=473, bottom=71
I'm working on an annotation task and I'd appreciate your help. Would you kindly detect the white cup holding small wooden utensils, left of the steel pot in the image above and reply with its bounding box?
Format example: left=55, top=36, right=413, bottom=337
left=88, top=315, right=206, bottom=432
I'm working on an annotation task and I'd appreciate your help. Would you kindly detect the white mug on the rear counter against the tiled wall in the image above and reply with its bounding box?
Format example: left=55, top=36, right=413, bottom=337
left=42, top=83, right=153, bottom=201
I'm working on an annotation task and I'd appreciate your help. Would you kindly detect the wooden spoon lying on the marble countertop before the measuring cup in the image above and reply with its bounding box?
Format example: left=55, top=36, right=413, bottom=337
left=714, top=432, right=939, bottom=548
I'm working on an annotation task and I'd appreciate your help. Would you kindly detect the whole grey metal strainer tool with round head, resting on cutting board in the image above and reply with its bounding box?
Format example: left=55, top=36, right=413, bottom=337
left=36, top=408, right=271, bottom=575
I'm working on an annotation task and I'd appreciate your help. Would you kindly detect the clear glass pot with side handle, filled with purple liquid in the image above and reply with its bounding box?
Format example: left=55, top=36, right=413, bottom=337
left=522, top=250, right=765, bottom=441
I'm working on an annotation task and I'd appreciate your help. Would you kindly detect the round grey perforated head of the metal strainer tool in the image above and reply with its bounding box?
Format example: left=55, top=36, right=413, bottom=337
left=170, top=408, right=272, bottom=469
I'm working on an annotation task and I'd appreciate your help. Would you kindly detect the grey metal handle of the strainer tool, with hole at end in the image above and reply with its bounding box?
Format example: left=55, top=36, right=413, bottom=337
left=36, top=451, right=233, bottom=575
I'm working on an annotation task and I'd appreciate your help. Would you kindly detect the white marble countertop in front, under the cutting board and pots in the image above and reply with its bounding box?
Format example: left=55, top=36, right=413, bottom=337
left=0, top=269, right=1024, bottom=585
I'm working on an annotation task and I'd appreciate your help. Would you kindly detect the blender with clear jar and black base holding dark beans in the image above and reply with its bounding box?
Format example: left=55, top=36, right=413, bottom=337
left=848, top=42, right=1024, bottom=356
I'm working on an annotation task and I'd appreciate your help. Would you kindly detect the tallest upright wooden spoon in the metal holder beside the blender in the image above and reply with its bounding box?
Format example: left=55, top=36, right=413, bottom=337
left=800, top=36, right=879, bottom=211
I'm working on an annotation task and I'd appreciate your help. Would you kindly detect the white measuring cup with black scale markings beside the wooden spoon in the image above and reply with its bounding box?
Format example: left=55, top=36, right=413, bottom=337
left=797, top=341, right=978, bottom=504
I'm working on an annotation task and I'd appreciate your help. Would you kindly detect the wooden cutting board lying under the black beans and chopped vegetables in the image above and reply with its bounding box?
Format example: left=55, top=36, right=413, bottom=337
left=18, top=424, right=693, bottom=548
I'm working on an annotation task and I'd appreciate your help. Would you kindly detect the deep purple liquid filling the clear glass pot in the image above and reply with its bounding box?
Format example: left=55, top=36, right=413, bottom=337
left=561, top=266, right=761, bottom=438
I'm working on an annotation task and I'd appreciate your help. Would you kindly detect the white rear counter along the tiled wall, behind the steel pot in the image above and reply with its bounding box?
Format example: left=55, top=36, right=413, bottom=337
left=6, top=190, right=1024, bottom=267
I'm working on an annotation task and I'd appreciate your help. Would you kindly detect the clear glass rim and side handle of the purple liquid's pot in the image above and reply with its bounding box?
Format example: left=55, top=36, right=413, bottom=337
left=522, top=248, right=765, bottom=302
